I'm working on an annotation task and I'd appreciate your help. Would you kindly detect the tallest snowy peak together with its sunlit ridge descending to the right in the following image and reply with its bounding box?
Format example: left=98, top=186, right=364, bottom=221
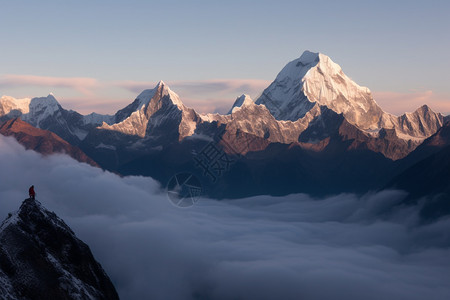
left=256, top=51, right=443, bottom=144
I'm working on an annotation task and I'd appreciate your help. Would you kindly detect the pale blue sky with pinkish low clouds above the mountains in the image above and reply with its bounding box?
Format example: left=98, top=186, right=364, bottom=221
left=0, top=1, right=450, bottom=113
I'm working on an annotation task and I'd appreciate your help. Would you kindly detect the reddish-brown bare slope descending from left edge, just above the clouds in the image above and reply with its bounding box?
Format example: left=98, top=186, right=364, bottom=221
left=0, top=118, right=98, bottom=167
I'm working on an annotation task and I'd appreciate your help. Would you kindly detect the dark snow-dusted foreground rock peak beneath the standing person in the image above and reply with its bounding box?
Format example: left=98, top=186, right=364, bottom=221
left=0, top=199, right=119, bottom=299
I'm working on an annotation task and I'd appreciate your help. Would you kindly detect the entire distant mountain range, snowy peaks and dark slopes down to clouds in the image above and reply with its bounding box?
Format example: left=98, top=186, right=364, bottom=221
left=0, top=51, right=449, bottom=209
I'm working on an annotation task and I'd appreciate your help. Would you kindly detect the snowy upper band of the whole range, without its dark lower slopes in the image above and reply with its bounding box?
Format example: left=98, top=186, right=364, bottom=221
left=0, top=51, right=443, bottom=160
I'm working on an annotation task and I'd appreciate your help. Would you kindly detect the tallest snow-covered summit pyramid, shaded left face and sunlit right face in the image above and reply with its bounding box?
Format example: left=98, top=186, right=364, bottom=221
left=256, top=51, right=383, bottom=129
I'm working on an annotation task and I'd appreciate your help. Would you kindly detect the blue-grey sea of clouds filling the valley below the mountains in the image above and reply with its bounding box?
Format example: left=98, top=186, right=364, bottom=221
left=0, top=136, right=450, bottom=300
